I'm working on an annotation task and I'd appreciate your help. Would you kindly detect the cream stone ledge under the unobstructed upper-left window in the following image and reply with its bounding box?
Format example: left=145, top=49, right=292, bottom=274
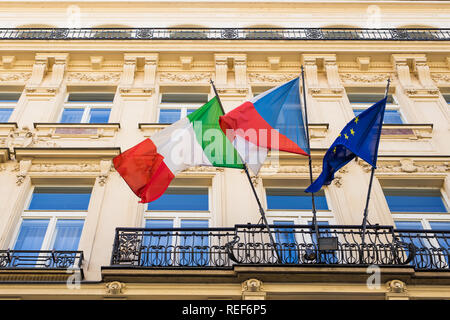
left=33, top=123, right=120, bottom=139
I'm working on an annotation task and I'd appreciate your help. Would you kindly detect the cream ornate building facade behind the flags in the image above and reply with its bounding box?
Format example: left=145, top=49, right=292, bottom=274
left=0, top=1, right=450, bottom=300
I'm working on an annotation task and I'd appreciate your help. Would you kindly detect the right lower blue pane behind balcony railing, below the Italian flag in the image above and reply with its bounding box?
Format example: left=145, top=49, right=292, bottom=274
left=178, top=220, right=209, bottom=266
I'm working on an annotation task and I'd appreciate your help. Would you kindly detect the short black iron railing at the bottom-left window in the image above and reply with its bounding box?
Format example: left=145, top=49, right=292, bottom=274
left=0, top=250, right=83, bottom=269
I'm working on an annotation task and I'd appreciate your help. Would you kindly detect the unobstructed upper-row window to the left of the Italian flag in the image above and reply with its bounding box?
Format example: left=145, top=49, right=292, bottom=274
left=60, top=93, right=114, bottom=123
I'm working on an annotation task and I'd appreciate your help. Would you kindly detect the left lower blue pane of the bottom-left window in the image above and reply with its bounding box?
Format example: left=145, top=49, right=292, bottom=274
left=14, top=219, right=50, bottom=250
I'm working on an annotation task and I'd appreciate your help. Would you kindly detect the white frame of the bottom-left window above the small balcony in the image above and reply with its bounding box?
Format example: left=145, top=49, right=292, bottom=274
left=9, top=185, right=92, bottom=251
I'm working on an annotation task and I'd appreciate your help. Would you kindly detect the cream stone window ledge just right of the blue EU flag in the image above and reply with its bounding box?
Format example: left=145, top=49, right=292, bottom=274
left=381, top=123, right=433, bottom=140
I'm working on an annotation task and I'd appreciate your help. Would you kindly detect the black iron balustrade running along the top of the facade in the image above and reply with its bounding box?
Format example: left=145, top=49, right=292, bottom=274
left=0, top=28, right=450, bottom=41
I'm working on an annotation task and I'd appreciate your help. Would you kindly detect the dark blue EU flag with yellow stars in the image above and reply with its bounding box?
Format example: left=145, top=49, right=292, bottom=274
left=305, top=97, right=387, bottom=193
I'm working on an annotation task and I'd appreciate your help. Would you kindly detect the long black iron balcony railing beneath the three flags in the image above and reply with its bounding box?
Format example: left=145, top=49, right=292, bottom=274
left=111, top=225, right=450, bottom=271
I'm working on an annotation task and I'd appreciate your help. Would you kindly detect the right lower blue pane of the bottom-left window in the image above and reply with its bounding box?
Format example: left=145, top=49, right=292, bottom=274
left=53, top=219, right=84, bottom=251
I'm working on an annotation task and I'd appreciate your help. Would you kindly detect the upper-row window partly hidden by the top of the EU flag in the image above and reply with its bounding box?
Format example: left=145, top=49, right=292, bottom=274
left=348, top=94, right=405, bottom=124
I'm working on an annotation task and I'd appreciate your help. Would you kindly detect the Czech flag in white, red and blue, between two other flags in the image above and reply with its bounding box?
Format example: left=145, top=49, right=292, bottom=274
left=219, top=78, right=309, bottom=174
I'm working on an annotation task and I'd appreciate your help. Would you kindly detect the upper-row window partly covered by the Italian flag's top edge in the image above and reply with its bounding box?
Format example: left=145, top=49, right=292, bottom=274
left=158, top=93, right=208, bottom=123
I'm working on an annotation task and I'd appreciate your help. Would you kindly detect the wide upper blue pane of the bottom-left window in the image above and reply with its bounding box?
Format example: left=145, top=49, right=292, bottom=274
left=28, top=187, right=92, bottom=210
